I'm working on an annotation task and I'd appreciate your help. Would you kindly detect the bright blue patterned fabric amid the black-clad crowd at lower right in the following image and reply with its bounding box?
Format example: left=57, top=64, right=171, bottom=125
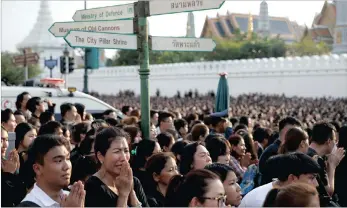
left=240, top=164, right=259, bottom=196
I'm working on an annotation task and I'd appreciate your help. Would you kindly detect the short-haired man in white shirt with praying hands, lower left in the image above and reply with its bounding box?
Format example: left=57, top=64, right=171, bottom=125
left=18, top=134, right=85, bottom=207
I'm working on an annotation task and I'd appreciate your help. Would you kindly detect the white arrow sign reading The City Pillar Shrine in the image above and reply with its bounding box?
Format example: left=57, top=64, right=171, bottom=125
left=64, top=31, right=137, bottom=50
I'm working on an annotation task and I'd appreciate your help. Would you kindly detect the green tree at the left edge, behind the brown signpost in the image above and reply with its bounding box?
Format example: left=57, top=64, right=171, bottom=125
left=1, top=52, right=42, bottom=85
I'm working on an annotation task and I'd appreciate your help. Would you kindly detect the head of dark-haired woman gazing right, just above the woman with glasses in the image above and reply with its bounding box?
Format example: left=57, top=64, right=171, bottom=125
left=180, top=142, right=212, bottom=175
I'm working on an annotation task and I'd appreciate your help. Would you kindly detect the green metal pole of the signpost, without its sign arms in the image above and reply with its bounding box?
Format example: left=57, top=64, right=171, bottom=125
left=136, top=1, right=150, bottom=139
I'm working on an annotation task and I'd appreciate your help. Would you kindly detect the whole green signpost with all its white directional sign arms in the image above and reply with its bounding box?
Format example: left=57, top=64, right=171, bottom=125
left=49, top=0, right=224, bottom=139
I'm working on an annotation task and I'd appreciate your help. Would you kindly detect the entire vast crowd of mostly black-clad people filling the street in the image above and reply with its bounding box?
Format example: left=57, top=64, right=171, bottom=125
left=1, top=92, right=347, bottom=207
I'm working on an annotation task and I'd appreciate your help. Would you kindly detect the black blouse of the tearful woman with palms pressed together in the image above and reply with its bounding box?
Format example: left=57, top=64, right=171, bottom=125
left=84, top=176, right=148, bottom=207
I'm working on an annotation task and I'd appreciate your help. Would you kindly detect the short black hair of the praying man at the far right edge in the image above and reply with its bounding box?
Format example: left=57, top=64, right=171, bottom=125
left=311, top=121, right=336, bottom=145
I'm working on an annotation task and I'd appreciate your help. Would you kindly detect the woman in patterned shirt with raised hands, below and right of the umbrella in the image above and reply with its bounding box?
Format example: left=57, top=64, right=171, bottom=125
left=228, top=134, right=251, bottom=182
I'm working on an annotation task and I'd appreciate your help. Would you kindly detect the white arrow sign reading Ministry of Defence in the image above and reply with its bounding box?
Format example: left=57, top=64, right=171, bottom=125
left=72, top=4, right=135, bottom=21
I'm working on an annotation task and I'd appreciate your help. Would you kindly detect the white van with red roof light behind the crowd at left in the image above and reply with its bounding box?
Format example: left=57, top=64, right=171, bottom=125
left=1, top=86, right=124, bottom=120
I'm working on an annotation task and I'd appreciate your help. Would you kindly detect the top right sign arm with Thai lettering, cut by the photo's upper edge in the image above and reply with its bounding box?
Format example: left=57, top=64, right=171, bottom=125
left=149, top=0, right=225, bottom=15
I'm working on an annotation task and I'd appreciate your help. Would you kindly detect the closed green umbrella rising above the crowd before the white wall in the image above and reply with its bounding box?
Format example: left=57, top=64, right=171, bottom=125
left=215, top=73, right=230, bottom=112
